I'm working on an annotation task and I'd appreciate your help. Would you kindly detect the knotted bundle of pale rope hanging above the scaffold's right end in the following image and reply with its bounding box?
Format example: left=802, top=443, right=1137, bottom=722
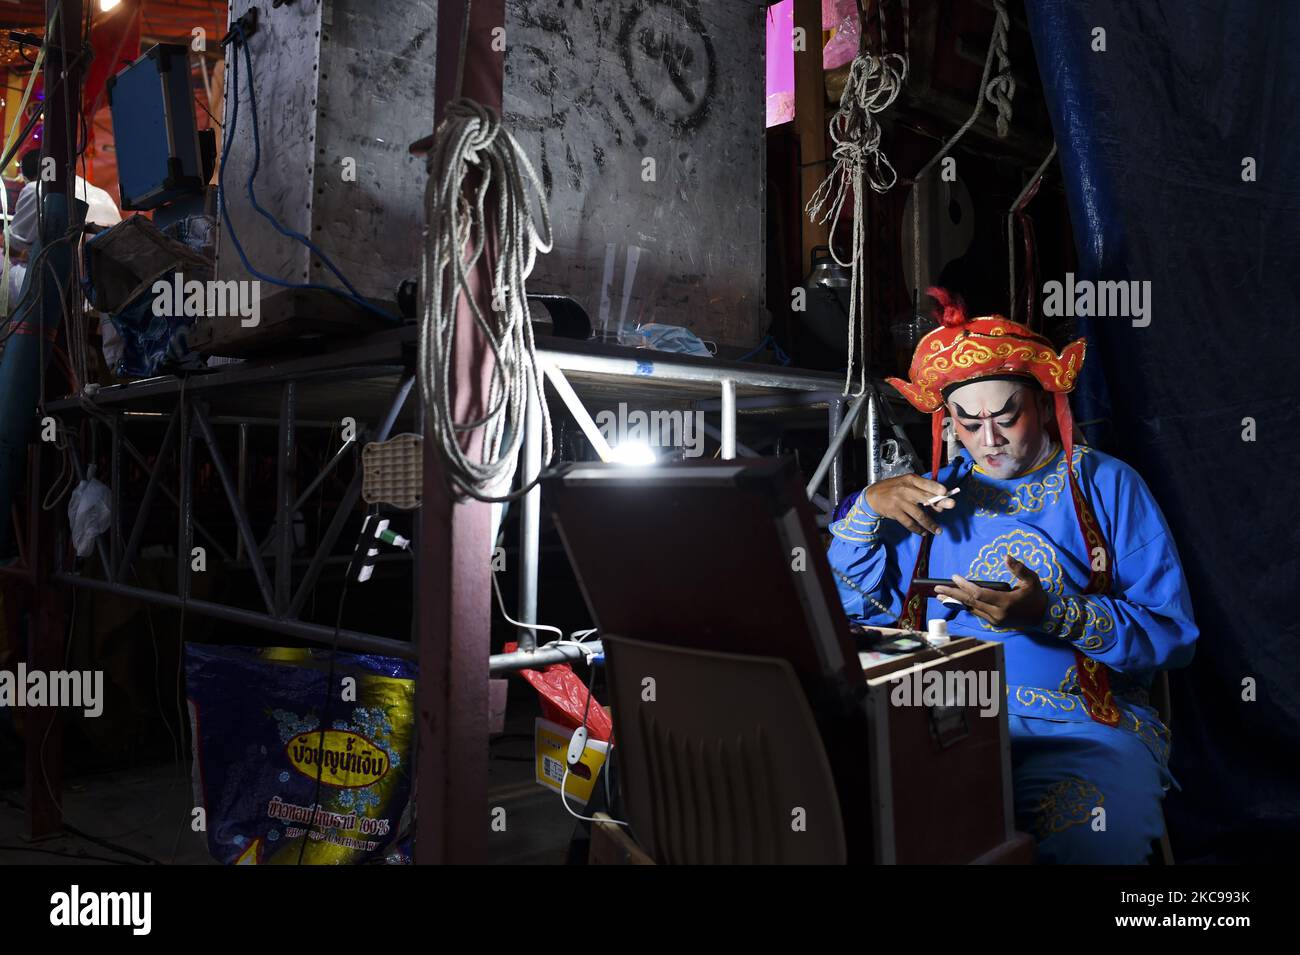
left=803, top=3, right=907, bottom=398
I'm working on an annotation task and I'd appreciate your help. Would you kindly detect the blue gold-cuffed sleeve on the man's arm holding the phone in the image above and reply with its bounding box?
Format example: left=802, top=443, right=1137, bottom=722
left=1041, top=463, right=1199, bottom=682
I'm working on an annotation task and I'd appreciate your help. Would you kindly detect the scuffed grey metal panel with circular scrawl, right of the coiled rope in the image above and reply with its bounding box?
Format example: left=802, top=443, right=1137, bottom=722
left=504, top=0, right=767, bottom=347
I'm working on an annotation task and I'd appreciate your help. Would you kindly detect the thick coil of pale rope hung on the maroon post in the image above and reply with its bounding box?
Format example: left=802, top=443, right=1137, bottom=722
left=419, top=99, right=553, bottom=502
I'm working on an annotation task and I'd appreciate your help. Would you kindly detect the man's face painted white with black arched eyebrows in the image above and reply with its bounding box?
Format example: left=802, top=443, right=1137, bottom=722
left=948, top=381, right=1056, bottom=478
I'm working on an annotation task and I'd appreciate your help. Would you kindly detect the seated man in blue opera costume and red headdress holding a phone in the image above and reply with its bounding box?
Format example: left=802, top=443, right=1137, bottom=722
left=828, top=290, right=1197, bottom=863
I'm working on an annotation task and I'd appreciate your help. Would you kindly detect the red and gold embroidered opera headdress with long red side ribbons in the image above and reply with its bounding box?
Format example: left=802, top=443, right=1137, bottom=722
left=885, top=288, right=1110, bottom=628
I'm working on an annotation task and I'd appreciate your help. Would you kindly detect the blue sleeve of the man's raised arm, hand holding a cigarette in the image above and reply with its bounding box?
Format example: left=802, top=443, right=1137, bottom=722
left=827, top=494, right=920, bottom=626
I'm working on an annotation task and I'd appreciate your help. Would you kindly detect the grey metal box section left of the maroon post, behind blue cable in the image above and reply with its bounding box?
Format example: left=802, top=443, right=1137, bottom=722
left=217, top=0, right=437, bottom=317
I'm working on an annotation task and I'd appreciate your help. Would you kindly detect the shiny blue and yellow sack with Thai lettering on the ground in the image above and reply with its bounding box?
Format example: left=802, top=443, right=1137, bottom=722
left=185, top=643, right=415, bottom=865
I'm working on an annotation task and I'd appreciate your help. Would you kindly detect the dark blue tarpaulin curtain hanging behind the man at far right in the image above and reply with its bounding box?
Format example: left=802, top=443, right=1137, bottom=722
left=1026, top=0, right=1300, bottom=863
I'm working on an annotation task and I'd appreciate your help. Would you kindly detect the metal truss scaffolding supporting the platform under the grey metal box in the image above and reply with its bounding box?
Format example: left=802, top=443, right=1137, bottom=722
left=48, top=326, right=915, bottom=673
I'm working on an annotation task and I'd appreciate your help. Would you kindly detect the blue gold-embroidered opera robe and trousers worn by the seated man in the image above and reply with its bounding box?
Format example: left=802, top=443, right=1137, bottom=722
left=828, top=447, right=1197, bottom=863
